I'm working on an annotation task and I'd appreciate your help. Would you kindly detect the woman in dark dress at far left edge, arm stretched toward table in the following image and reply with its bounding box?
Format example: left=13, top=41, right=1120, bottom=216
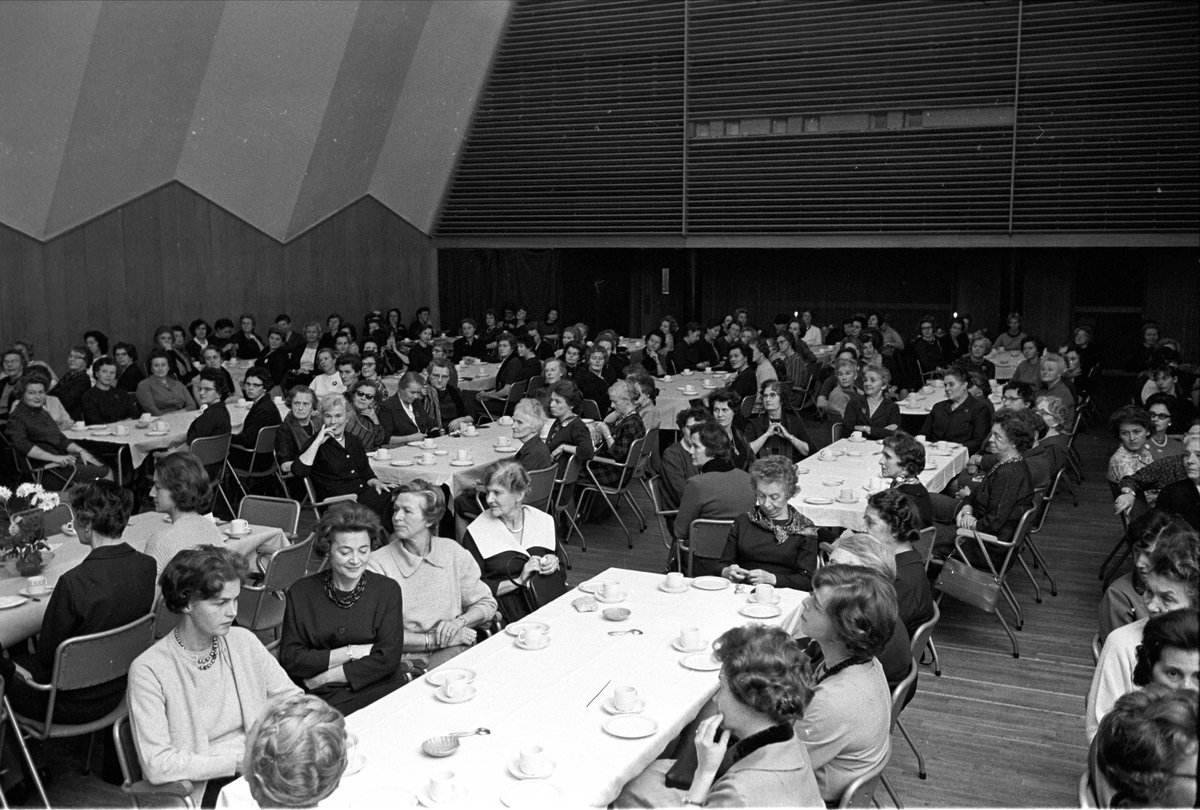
left=6, top=370, right=113, bottom=490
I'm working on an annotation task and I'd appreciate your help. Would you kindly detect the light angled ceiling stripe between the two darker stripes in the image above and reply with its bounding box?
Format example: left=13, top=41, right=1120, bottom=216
left=176, top=0, right=359, bottom=239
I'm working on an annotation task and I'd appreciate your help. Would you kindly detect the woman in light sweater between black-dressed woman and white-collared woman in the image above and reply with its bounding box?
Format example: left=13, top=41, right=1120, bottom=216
left=367, top=479, right=496, bottom=670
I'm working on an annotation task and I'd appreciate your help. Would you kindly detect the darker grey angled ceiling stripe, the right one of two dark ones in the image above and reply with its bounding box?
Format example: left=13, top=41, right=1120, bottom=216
left=287, top=0, right=433, bottom=239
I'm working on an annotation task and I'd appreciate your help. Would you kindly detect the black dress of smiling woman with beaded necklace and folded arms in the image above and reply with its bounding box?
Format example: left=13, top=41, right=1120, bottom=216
left=280, top=571, right=407, bottom=714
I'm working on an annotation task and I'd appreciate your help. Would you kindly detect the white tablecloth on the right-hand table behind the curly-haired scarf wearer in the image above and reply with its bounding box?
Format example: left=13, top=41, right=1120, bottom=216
left=790, top=439, right=967, bottom=532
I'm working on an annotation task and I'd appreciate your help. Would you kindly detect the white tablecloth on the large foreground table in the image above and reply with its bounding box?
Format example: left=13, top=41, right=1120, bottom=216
left=217, top=569, right=805, bottom=808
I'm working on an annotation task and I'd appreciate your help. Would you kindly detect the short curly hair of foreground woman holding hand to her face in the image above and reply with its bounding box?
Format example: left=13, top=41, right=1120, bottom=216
left=713, top=624, right=812, bottom=724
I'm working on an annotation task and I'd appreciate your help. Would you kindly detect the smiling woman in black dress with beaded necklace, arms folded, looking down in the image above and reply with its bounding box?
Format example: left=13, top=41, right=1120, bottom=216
left=280, top=503, right=408, bottom=714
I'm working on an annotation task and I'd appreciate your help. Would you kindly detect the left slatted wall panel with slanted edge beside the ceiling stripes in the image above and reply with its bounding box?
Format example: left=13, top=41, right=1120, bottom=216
left=438, top=0, right=684, bottom=236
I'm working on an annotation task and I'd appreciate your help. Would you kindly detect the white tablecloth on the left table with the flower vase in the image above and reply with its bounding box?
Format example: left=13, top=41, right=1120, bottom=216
left=0, top=512, right=288, bottom=648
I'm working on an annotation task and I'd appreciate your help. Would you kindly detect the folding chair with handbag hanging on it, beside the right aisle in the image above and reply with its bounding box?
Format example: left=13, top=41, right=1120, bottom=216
left=936, top=506, right=1034, bottom=658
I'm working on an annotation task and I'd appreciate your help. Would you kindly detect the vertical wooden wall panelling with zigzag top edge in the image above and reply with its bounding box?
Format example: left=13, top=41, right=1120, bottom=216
left=0, top=182, right=438, bottom=368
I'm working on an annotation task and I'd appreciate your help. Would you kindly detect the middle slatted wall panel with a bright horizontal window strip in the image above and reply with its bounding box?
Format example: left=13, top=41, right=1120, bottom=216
left=688, top=0, right=1016, bottom=234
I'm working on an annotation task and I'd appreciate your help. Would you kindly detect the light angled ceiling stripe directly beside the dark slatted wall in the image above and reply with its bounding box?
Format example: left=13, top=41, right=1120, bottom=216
left=371, top=0, right=511, bottom=233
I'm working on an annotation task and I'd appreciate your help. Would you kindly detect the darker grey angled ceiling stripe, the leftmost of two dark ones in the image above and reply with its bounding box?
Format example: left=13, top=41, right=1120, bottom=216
left=44, top=0, right=224, bottom=236
